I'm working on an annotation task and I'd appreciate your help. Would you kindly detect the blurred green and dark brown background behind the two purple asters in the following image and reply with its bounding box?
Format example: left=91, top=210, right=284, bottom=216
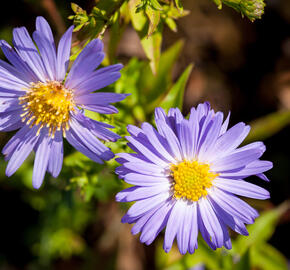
left=0, top=0, right=290, bottom=270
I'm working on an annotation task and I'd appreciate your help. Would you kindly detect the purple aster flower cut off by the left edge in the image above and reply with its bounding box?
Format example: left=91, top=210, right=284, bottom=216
left=0, top=17, right=126, bottom=188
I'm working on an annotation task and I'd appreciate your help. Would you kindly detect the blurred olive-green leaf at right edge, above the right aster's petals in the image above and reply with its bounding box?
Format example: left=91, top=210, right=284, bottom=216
left=245, top=111, right=290, bottom=143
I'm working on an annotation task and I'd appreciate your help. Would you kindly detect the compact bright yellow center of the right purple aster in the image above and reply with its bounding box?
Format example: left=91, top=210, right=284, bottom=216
left=170, top=160, right=218, bottom=201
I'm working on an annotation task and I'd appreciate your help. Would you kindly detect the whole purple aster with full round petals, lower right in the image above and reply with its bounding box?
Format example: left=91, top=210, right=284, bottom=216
left=116, top=103, right=272, bottom=254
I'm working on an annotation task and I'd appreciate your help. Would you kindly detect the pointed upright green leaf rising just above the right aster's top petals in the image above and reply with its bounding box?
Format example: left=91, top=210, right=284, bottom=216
left=160, top=64, right=193, bottom=110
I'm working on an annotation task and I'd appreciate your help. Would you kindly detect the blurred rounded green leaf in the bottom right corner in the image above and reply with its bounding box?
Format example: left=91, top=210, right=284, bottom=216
left=251, top=243, right=288, bottom=270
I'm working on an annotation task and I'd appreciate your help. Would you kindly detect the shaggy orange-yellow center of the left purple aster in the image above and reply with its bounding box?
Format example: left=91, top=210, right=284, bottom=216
left=19, top=81, right=75, bottom=137
